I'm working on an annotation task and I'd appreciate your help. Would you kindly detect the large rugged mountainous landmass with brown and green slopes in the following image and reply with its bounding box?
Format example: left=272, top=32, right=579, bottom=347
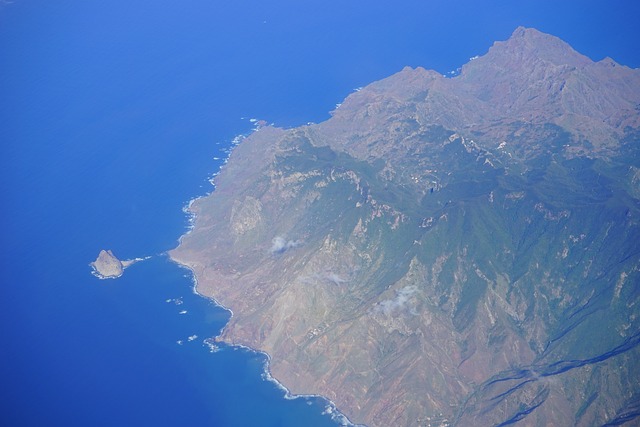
left=171, top=28, right=640, bottom=427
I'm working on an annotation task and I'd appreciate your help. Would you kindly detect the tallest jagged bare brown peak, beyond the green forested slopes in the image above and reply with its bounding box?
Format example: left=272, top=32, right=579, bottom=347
left=457, top=28, right=640, bottom=145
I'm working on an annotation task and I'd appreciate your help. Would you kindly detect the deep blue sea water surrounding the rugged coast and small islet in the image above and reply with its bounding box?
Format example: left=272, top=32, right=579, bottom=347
left=0, top=0, right=640, bottom=426
